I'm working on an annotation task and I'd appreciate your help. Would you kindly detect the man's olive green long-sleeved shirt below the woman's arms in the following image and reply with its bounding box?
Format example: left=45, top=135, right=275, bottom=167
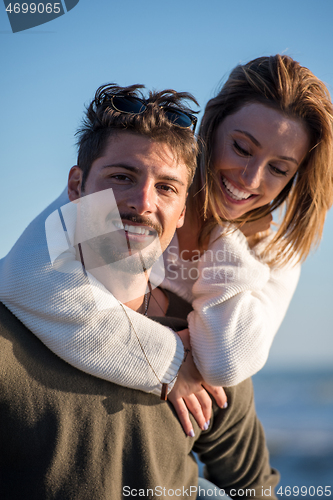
left=0, top=299, right=278, bottom=500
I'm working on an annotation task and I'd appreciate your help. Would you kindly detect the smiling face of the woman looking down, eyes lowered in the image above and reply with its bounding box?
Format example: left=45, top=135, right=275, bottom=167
left=213, top=103, right=310, bottom=220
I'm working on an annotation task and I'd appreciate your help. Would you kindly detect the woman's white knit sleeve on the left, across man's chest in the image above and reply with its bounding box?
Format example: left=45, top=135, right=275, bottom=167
left=0, top=190, right=184, bottom=395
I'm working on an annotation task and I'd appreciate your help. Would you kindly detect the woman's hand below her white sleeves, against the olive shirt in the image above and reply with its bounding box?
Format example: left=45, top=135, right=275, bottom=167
left=168, top=329, right=227, bottom=437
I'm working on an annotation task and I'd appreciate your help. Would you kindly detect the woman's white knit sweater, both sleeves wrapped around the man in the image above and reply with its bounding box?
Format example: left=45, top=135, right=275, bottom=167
left=0, top=192, right=299, bottom=395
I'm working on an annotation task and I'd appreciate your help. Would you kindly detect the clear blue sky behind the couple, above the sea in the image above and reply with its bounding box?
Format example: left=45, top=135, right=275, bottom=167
left=0, top=0, right=333, bottom=368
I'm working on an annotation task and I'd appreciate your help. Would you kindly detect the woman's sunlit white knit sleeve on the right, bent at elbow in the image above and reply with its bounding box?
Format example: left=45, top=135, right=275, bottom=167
left=188, top=230, right=300, bottom=386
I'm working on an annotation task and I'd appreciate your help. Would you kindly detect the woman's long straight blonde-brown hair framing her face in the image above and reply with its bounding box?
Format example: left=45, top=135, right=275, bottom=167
left=189, top=55, right=333, bottom=263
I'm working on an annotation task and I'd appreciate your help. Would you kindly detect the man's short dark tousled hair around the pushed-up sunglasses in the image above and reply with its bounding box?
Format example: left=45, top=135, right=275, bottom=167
left=76, top=84, right=198, bottom=190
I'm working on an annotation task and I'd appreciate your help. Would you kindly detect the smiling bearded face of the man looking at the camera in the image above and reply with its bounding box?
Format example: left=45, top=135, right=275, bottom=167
left=68, top=132, right=188, bottom=273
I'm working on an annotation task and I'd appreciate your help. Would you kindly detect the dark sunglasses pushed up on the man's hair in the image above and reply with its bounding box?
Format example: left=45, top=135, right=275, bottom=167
left=99, top=94, right=197, bottom=133
